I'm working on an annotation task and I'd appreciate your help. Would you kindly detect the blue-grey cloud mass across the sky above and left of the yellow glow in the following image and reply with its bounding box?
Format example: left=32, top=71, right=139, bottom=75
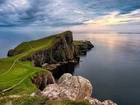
left=0, top=0, right=140, bottom=27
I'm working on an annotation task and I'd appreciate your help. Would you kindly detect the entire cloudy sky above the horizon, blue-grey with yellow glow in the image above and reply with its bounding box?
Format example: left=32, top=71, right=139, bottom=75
left=0, top=0, right=140, bottom=31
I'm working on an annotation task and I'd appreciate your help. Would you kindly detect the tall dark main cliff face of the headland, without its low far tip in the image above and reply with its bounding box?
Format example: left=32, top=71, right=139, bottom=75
left=30, top=32, right=74, bottom=66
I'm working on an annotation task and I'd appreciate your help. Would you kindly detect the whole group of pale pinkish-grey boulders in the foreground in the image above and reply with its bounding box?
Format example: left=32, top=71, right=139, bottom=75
left=31, top=73, right=117, bottom=105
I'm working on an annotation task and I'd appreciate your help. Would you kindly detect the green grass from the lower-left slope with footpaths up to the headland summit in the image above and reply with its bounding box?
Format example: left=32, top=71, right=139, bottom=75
left=0, top=31, right=71, bottom=96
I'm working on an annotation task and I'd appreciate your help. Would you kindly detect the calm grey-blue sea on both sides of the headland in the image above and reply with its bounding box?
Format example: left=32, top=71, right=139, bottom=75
left=0, top=31, right=140, bottom=105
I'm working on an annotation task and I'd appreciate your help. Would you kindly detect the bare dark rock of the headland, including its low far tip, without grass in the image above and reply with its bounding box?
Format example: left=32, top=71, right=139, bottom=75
left=7, top=31, right=93, bottom=67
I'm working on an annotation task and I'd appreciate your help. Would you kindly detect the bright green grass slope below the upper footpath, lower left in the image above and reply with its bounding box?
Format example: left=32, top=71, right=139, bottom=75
left=0, top=55, right=48, bottom=95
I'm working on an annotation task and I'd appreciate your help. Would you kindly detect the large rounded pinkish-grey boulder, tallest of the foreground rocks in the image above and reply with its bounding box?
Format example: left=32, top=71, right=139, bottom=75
left=58, top=73, right=92, bottom=99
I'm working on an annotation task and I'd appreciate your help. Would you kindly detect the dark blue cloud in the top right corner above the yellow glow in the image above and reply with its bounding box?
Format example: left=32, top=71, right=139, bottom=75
left=87, top=0, right=140, bottom=15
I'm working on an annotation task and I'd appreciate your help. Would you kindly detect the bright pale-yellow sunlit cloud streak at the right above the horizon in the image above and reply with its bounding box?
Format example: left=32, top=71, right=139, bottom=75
left=84, top=9, right=140, bottom=25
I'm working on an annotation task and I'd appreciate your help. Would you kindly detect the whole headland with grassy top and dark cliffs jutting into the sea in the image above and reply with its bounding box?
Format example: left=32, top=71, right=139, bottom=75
left=7, top=31, right=94, bottom=67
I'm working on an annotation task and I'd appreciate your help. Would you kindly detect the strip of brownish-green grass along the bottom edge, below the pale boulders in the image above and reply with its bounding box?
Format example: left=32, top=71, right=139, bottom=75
left=0, top=96, right=90, bottom=105
